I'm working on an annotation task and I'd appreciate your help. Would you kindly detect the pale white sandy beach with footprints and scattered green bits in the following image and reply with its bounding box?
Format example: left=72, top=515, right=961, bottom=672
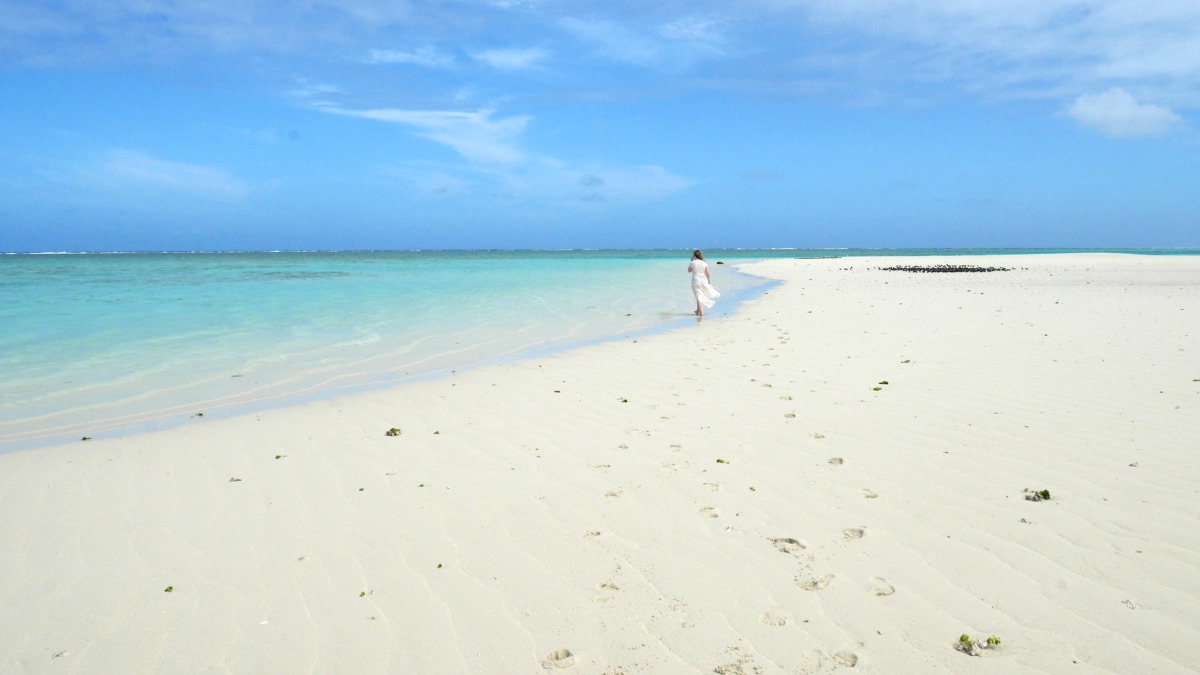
left=0, top=255, right=1200, bottom=675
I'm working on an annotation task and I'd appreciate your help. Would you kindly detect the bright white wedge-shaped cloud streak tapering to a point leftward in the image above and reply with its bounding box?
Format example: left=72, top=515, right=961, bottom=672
left=317, top=106, right=529, bottom=163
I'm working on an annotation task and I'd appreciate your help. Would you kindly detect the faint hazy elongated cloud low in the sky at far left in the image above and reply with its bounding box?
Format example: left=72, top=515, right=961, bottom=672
left=85, top=148, right=251, bottom=199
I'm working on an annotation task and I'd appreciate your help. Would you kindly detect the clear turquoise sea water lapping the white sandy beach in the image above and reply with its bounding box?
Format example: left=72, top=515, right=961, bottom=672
left=0, top=249, right=1198, bottom=449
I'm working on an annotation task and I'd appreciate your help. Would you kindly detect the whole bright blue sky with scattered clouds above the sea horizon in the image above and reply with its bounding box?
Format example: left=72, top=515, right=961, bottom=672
left=0, top=0, right=1200, bottom=251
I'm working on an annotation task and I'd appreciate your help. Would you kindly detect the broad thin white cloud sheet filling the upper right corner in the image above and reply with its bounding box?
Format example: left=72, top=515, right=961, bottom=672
left=777, top=0, right=1200, bottom=101
